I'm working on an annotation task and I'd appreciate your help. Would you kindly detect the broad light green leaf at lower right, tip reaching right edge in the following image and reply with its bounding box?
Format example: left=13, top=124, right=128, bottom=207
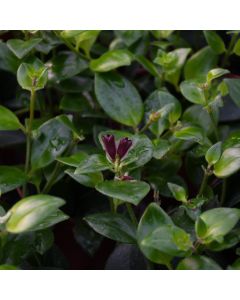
left=195, top=207, right=240, bottom=244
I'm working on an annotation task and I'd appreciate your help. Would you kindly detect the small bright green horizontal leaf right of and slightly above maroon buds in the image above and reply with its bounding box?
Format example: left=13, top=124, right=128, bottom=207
left=174, top=126, right=204, bottom=143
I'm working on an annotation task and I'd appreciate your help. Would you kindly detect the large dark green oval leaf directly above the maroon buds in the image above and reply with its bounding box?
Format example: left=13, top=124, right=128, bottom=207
left=95, top=73, right=143, bottom=127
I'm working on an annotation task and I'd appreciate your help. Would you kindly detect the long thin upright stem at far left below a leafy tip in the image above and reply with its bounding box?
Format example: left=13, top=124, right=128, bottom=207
left=23, top=89, right=36, bottom=196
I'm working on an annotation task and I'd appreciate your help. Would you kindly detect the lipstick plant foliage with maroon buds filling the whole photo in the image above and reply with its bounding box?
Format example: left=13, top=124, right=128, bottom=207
left=0, top=30, right=240, bottom=270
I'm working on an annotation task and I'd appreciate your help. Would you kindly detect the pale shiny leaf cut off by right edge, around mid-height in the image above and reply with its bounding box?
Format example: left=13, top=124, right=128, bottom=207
left=214, top=148, right=240, bottom=178
